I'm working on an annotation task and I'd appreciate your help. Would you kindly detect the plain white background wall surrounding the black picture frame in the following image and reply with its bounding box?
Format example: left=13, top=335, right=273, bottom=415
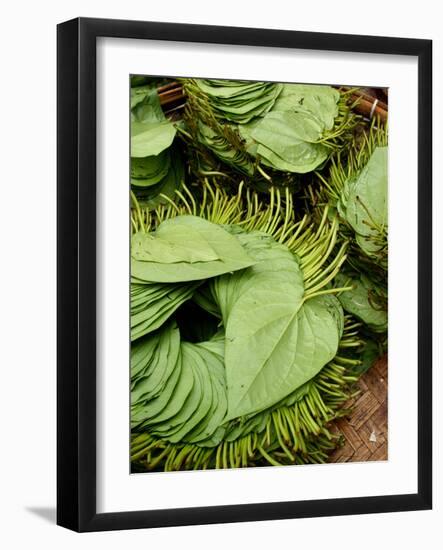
left=0, top=0, right=443, bottom=550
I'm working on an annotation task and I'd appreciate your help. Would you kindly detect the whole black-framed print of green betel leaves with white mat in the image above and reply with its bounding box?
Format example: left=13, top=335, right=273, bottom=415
left=57, top=18, right=432, bottom=531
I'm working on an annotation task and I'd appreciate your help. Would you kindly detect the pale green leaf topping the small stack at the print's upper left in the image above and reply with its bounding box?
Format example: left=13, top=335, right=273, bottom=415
left=131, top=120, right=176, bottom=157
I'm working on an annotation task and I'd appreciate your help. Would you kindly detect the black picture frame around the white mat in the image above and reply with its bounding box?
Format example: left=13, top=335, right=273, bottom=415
left=57, top=18, right=432, bottom=532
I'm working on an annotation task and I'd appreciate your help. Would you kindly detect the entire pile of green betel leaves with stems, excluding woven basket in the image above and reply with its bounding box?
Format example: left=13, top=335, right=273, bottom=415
left=131, top=76, right=388, bottom=472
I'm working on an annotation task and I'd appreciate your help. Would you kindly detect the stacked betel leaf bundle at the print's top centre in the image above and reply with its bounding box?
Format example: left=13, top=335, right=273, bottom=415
left=184, top=80, right=357, bottom=182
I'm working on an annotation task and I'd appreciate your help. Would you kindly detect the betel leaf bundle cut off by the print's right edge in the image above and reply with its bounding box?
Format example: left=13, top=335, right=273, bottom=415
left=317, top=122, right=388, bottom=364
